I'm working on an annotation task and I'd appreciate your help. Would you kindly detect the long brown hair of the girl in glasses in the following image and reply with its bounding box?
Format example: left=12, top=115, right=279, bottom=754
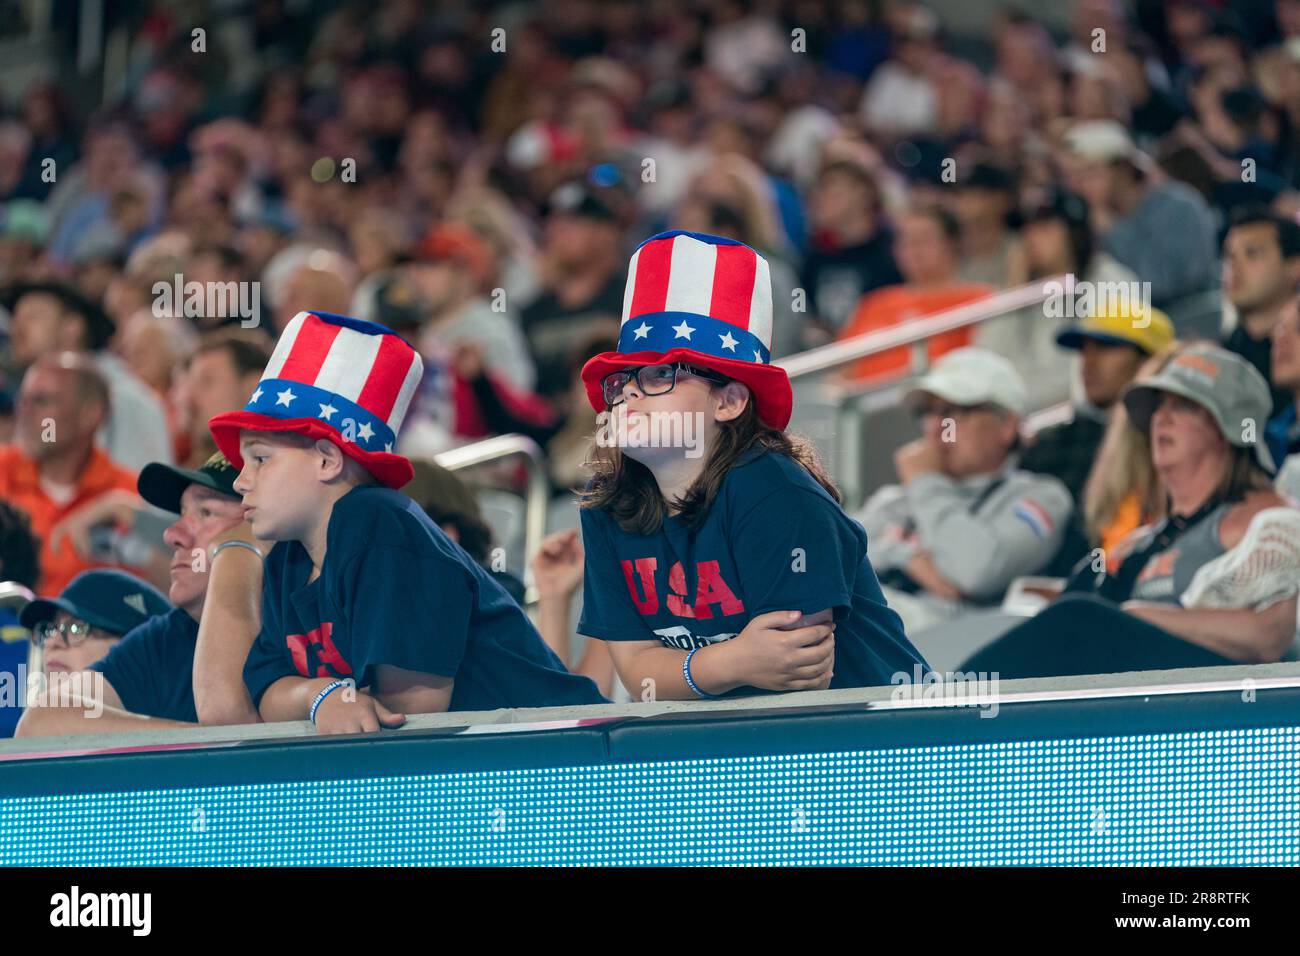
left=576, top=398, right=842, bottom=535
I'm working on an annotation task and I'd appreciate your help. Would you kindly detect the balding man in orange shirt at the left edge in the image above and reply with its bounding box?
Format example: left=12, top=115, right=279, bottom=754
left=0, top=352, right=135, bottom=596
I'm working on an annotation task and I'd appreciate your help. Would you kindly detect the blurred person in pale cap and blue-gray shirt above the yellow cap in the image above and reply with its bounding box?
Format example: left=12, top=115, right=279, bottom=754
left=1065, top=120, right=1214, bottom=311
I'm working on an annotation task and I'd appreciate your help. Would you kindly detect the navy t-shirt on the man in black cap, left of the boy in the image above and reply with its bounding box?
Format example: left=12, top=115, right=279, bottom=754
left=90, top=607, right=199, bottom=723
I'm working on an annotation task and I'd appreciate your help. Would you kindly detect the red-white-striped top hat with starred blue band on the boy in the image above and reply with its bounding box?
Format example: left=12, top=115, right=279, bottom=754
left=208, top=312, right=424, bottom=488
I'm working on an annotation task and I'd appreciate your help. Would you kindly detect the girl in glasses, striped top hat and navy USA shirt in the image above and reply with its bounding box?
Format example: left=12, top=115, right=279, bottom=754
left=579, top=232, right=926, bottom=700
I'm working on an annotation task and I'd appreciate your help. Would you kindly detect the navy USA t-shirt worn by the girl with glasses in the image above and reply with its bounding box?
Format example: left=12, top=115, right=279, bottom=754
left=577, top=449, right=928, bottom=696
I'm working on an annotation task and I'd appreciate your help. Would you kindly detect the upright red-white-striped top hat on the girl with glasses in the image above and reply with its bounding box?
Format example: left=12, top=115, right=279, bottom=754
left=582, top=229, right=793, bottom=428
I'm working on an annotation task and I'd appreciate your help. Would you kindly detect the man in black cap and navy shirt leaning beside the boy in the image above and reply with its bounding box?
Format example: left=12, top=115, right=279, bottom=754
left=17, top=453, right=261, bottom=736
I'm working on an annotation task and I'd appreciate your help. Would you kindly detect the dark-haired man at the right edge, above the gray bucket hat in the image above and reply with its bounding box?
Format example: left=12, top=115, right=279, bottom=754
left=1223, top=207, right=1300, bottom=415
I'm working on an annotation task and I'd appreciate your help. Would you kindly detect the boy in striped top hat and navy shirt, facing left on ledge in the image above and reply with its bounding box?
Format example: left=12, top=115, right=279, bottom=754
left=209, top=312, right=603, bottom=734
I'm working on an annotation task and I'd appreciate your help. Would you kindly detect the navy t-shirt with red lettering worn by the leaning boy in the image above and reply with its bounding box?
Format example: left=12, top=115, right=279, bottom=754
left=244, top=485, right=606, bottom=710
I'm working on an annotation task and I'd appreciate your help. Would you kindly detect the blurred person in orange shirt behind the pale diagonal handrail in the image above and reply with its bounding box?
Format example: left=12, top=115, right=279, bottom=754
left=840, top=206, right=993, bottom=381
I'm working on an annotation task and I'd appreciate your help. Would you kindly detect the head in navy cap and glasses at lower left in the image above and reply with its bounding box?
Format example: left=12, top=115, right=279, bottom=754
left=18, top=568, right=172, bottom=676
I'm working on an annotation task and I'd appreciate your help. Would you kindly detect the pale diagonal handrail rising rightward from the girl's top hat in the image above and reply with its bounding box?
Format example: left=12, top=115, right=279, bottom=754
left=772, top=276, right=1065, bottom=380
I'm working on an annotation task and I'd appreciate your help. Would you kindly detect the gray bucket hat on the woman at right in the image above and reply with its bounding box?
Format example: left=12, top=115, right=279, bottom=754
left=1125, top=345, right=1275, bottom=472
